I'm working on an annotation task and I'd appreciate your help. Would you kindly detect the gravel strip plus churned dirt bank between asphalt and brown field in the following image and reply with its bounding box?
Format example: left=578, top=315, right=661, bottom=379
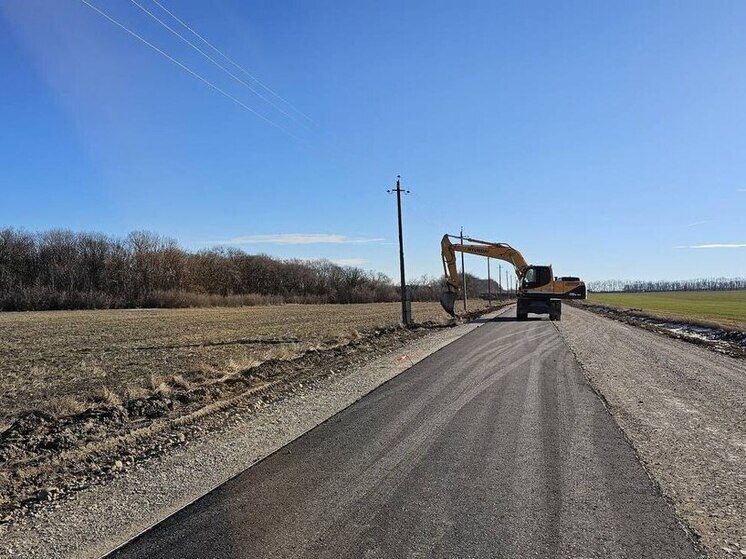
left=0, top=306, right=506, bottom=558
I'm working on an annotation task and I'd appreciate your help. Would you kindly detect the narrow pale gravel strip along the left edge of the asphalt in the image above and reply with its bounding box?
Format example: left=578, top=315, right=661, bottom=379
left=0, top=307, right=512, bottom=559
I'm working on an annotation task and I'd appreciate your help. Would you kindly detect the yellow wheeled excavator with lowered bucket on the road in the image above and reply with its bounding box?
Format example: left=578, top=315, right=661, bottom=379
left=440, top=235, right=586, bottom=320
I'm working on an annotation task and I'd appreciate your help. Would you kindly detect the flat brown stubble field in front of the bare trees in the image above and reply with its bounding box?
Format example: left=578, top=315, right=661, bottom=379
left=0, top=301, right=484, bottom=426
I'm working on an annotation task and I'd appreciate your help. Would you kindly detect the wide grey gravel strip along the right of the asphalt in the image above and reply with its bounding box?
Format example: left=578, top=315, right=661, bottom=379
left=556, top=305, right=746, bottom=559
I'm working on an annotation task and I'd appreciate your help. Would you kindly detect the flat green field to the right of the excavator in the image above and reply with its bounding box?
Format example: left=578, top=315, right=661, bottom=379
left=588, top=290, right=746, bottom=330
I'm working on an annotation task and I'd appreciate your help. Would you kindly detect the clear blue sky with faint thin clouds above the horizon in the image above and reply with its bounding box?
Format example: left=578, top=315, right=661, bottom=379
left=0, top=0, right=746, bottom=280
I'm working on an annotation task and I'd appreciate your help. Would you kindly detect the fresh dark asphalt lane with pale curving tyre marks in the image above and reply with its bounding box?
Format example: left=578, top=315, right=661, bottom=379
left=113, top=317, right=698, bottom=559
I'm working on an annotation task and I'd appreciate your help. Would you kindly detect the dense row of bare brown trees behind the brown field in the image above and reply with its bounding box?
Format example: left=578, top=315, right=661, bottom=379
left=0, top=228, right=506, bottom=311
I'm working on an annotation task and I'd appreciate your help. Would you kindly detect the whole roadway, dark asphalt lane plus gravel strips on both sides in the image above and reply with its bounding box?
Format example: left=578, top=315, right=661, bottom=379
left=0, top=306, right=746, bottom=558
